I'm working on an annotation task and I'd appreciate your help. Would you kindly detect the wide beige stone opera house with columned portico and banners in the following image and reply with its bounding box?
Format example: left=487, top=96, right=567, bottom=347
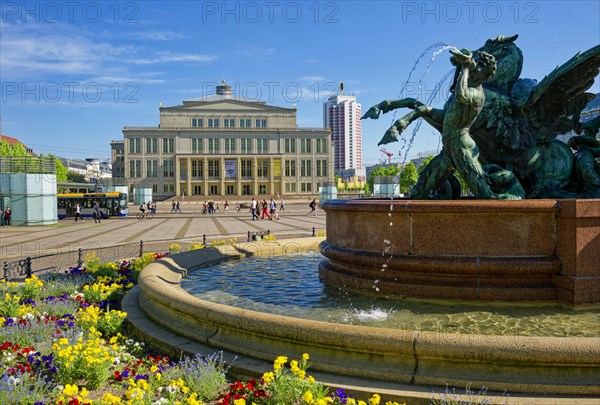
left=117, top=84, right=333, bottom=200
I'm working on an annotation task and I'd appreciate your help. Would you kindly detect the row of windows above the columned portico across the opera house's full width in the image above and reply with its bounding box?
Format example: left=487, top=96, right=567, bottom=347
left=128, top=138, right=328, bottom=154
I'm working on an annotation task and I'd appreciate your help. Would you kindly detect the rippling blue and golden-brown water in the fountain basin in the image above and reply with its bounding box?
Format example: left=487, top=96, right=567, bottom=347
left=181, top=252, right=600, bottom=337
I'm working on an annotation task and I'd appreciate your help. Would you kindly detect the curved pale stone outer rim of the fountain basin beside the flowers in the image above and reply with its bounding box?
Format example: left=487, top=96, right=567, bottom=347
left=139, top=238, right=600, bottom=396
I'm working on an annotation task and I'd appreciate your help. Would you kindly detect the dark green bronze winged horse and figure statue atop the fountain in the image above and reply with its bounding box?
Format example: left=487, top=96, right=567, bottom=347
left=363, top=35, right=600, bottom=199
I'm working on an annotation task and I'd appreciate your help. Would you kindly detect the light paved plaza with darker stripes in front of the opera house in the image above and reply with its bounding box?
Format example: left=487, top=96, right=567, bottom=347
left=0, top=200, right=325, bottom=279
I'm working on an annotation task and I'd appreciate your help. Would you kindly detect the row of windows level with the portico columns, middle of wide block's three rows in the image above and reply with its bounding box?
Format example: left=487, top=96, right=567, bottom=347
left=129, top=159, right=327, bottom=178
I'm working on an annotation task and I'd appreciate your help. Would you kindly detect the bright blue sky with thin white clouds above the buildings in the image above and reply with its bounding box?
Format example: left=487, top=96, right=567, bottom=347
left=0, top=0, right=600, bottom=164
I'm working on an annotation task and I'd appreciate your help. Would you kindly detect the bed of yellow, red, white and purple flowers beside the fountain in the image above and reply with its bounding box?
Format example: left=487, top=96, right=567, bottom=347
left=0, top=251, right=404, bottom=405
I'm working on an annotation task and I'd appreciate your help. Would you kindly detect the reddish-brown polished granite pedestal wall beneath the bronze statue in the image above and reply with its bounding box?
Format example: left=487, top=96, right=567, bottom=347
left=320, top=199, right=600, bottom=305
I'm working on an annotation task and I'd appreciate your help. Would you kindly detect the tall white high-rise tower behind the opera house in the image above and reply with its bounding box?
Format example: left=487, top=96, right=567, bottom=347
left=323, top=94, right=362, bottom=174
